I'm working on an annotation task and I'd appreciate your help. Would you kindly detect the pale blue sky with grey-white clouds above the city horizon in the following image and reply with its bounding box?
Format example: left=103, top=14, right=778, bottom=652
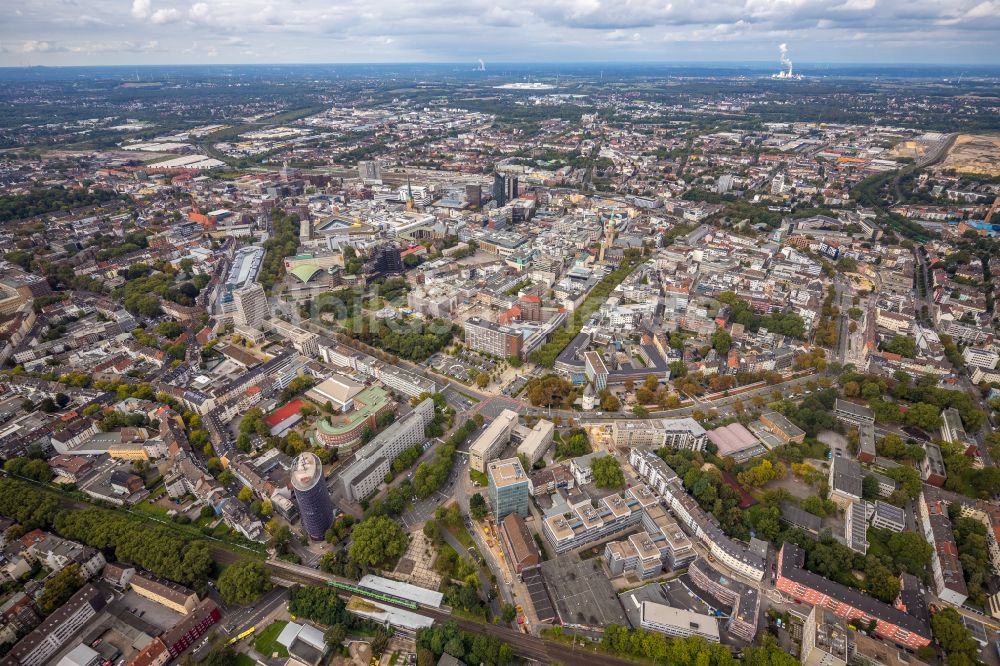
left=0, top=0, right=1000, bottom=68
